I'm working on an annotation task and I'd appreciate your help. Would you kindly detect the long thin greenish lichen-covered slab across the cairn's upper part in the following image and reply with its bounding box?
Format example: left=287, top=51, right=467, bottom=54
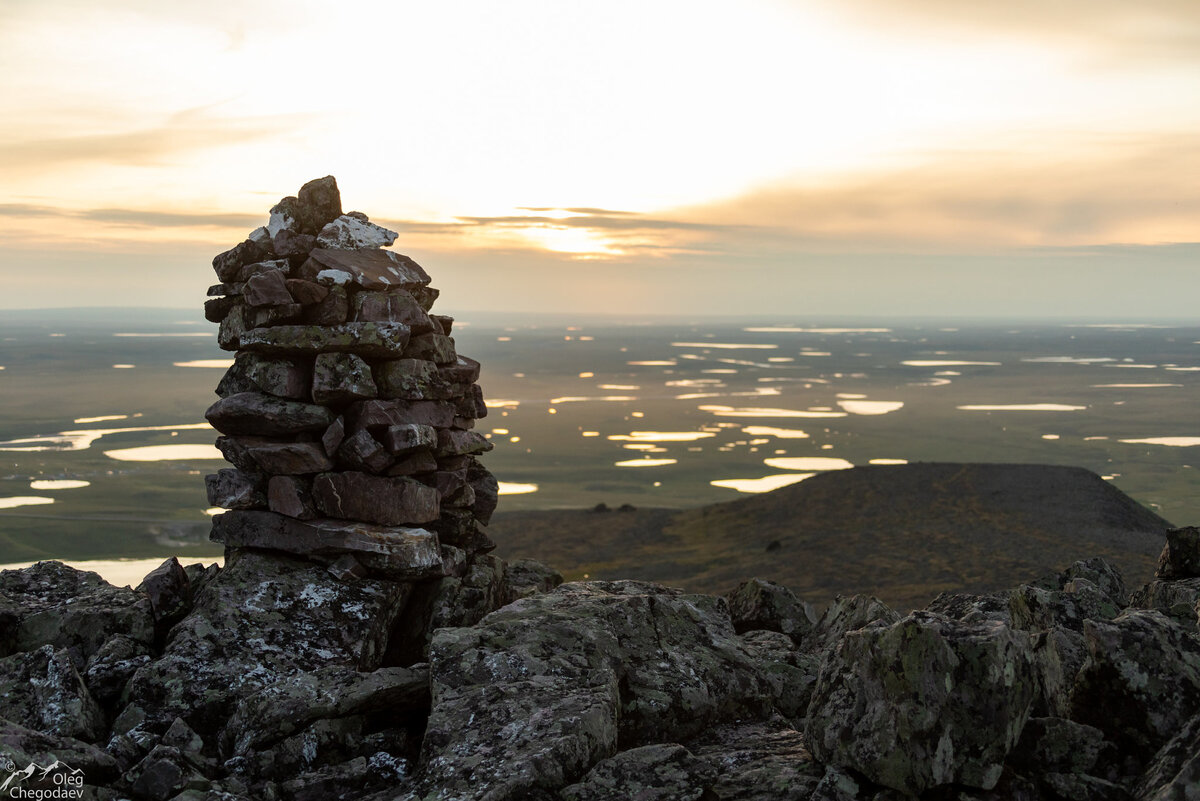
left=238, top=323, right=409, bottom=359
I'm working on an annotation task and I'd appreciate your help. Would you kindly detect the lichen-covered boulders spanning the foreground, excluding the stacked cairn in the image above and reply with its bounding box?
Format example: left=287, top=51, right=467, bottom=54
left=0, top=528, right=1200, bottom=801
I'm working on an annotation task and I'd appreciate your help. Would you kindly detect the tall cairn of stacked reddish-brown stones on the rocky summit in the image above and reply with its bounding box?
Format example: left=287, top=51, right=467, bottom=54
left=204, top=176, right=497, bottom=582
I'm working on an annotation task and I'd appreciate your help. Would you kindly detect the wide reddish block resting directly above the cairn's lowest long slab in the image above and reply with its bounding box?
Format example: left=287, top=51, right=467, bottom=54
left=312, top=472, right=439, bottom=525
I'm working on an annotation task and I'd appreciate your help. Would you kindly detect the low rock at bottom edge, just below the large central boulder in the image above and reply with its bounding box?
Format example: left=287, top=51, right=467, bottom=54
left=559, top=742, right=718, bottom=801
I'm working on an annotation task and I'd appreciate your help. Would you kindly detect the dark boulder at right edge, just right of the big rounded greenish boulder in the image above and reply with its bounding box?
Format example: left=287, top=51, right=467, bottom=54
left=1070, top=609, right=1200, bottom=761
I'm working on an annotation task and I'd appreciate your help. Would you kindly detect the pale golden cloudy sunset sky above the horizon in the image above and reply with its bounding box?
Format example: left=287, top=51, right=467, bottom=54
left=0, top=0, right=1200, bottom=320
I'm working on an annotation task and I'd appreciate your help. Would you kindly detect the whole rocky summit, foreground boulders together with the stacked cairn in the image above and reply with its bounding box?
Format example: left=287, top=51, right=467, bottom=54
left=0, top=177, right=1200, bottom=801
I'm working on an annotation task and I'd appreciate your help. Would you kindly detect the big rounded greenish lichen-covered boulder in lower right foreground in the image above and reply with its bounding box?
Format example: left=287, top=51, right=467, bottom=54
left=805, top=612, right=1034, bottom=795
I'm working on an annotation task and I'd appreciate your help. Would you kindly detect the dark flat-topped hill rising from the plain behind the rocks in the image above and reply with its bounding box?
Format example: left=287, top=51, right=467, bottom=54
left=490, top=463, right=1171, bottom=608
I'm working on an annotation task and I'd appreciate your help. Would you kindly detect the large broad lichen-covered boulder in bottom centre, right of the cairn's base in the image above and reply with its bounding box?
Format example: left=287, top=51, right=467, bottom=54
left=422, top=582, right=768, bottom=801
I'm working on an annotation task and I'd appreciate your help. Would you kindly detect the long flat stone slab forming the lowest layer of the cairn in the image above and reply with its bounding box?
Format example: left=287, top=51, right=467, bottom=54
left=211, top=510, right=443, bottom=580
